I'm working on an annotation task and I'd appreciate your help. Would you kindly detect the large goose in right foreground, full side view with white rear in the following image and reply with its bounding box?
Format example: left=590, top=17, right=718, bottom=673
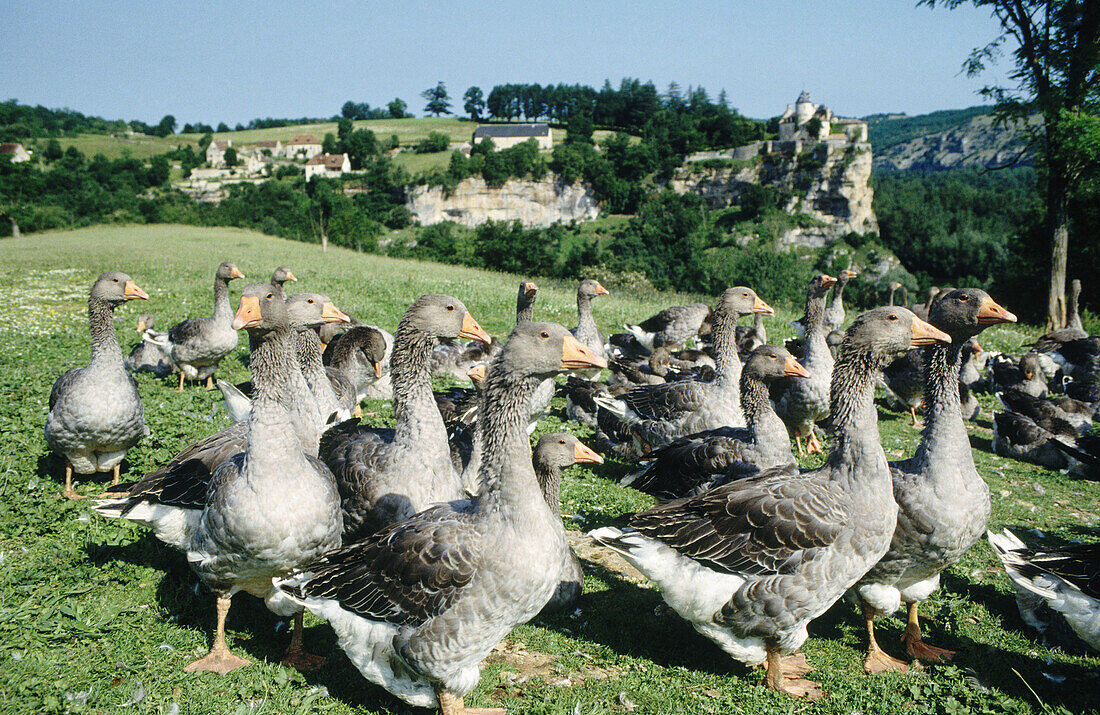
left=590, top=307, right=950, bottom=699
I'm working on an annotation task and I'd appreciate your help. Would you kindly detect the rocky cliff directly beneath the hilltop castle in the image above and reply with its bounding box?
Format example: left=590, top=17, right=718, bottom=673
left=669, top=141, right=879, bottom=236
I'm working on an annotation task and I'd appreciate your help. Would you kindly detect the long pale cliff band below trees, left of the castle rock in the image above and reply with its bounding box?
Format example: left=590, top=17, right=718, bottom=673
left=406, top=174, right=600, bottom=228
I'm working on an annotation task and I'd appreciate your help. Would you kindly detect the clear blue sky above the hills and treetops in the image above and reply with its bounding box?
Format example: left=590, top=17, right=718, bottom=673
left=0, top=0, right=1007, bottom=125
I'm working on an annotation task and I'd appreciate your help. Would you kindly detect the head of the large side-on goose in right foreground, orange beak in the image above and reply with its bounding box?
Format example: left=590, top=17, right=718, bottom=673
left=840, top=306, right=952, bottom=370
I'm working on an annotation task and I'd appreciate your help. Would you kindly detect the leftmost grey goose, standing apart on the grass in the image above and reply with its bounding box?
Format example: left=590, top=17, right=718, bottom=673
left=43, top=271, right=149, bottom=499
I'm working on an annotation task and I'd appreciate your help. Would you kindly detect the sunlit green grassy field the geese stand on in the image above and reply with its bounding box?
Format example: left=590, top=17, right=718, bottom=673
left=0, top=227, right=1100, bottom=715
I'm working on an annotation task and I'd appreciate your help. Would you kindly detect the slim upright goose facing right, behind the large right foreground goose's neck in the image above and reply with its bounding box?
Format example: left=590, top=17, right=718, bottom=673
left=776, top=273, right=836, bottom=455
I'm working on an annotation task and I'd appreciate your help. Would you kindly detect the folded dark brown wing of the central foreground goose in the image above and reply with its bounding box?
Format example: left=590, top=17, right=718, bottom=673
left=284, top=504, right=482, bottom=627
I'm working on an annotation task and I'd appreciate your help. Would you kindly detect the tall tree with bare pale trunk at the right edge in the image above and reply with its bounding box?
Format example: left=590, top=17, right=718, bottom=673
left=920, top=0, right=1100, bottom=329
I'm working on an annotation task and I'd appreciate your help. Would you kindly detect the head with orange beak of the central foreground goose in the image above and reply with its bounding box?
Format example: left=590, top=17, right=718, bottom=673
left=493, top=322, right=607, bottom=380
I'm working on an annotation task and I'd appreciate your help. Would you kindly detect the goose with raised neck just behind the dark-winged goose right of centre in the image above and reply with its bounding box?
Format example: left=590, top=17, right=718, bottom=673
left=601, top=286, right=776, bottom=449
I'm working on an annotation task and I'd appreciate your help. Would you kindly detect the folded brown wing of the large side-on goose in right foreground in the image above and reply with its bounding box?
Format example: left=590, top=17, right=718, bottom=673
left=630, top=464, right=848, bottom=574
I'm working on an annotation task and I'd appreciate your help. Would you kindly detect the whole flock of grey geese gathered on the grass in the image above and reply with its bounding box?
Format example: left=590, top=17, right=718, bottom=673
left=38, top=263, right=1100, bottom=715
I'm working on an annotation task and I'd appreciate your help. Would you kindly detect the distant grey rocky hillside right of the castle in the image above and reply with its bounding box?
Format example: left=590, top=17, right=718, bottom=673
left=875, top=114, right=1041, bottom=172
